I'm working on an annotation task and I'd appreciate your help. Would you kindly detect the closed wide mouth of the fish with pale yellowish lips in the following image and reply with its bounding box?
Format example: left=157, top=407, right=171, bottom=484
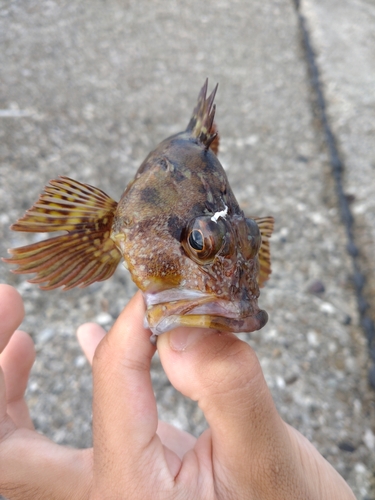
left=143, top=288, right=268, bottom=341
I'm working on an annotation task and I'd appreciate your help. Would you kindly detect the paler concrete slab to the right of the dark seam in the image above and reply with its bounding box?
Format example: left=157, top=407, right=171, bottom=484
left=301, top=0, right=375, bottom=364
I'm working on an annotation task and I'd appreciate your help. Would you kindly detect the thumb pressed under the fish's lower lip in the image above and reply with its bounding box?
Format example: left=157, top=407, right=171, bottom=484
left=158, top=328, right=306, bottom=498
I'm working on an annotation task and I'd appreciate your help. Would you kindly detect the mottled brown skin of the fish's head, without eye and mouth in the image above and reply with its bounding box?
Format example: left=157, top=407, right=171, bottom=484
left=113, top=132, right=259, bottom=324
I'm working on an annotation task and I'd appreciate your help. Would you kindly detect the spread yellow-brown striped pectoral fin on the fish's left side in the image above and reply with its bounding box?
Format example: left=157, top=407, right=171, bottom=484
left=3, top=177, right=121, bottom=290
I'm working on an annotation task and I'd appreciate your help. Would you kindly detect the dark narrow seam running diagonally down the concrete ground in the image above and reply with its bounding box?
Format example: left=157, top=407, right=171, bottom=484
left=293, top=0, right=375, bottom=389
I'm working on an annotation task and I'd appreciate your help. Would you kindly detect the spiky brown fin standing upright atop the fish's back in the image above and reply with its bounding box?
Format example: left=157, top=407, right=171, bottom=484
left=186, top=78, right=219, bottom=154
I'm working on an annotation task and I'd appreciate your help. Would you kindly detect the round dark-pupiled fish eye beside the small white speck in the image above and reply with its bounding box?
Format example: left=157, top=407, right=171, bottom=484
left=182, top=216, right=226, bottom=264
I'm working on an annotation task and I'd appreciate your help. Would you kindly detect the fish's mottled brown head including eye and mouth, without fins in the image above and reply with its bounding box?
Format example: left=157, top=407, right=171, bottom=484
left=112, top=132, right=267, bottom=335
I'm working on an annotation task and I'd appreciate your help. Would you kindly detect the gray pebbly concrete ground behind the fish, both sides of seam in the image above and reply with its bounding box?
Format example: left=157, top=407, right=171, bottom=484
left=0, top=0, right=375, bottom=500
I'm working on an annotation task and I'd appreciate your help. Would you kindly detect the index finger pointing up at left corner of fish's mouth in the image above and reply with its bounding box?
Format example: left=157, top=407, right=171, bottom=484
left=93, top=292, right=173, bottom=488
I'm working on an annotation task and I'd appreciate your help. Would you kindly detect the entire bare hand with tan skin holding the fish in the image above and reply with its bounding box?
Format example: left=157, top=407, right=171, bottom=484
left=0, top=285, right=355, bottom=500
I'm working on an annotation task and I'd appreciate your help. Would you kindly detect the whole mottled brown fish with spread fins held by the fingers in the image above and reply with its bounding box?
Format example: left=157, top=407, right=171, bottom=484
left=3, top=79, right=274, bottom=343
